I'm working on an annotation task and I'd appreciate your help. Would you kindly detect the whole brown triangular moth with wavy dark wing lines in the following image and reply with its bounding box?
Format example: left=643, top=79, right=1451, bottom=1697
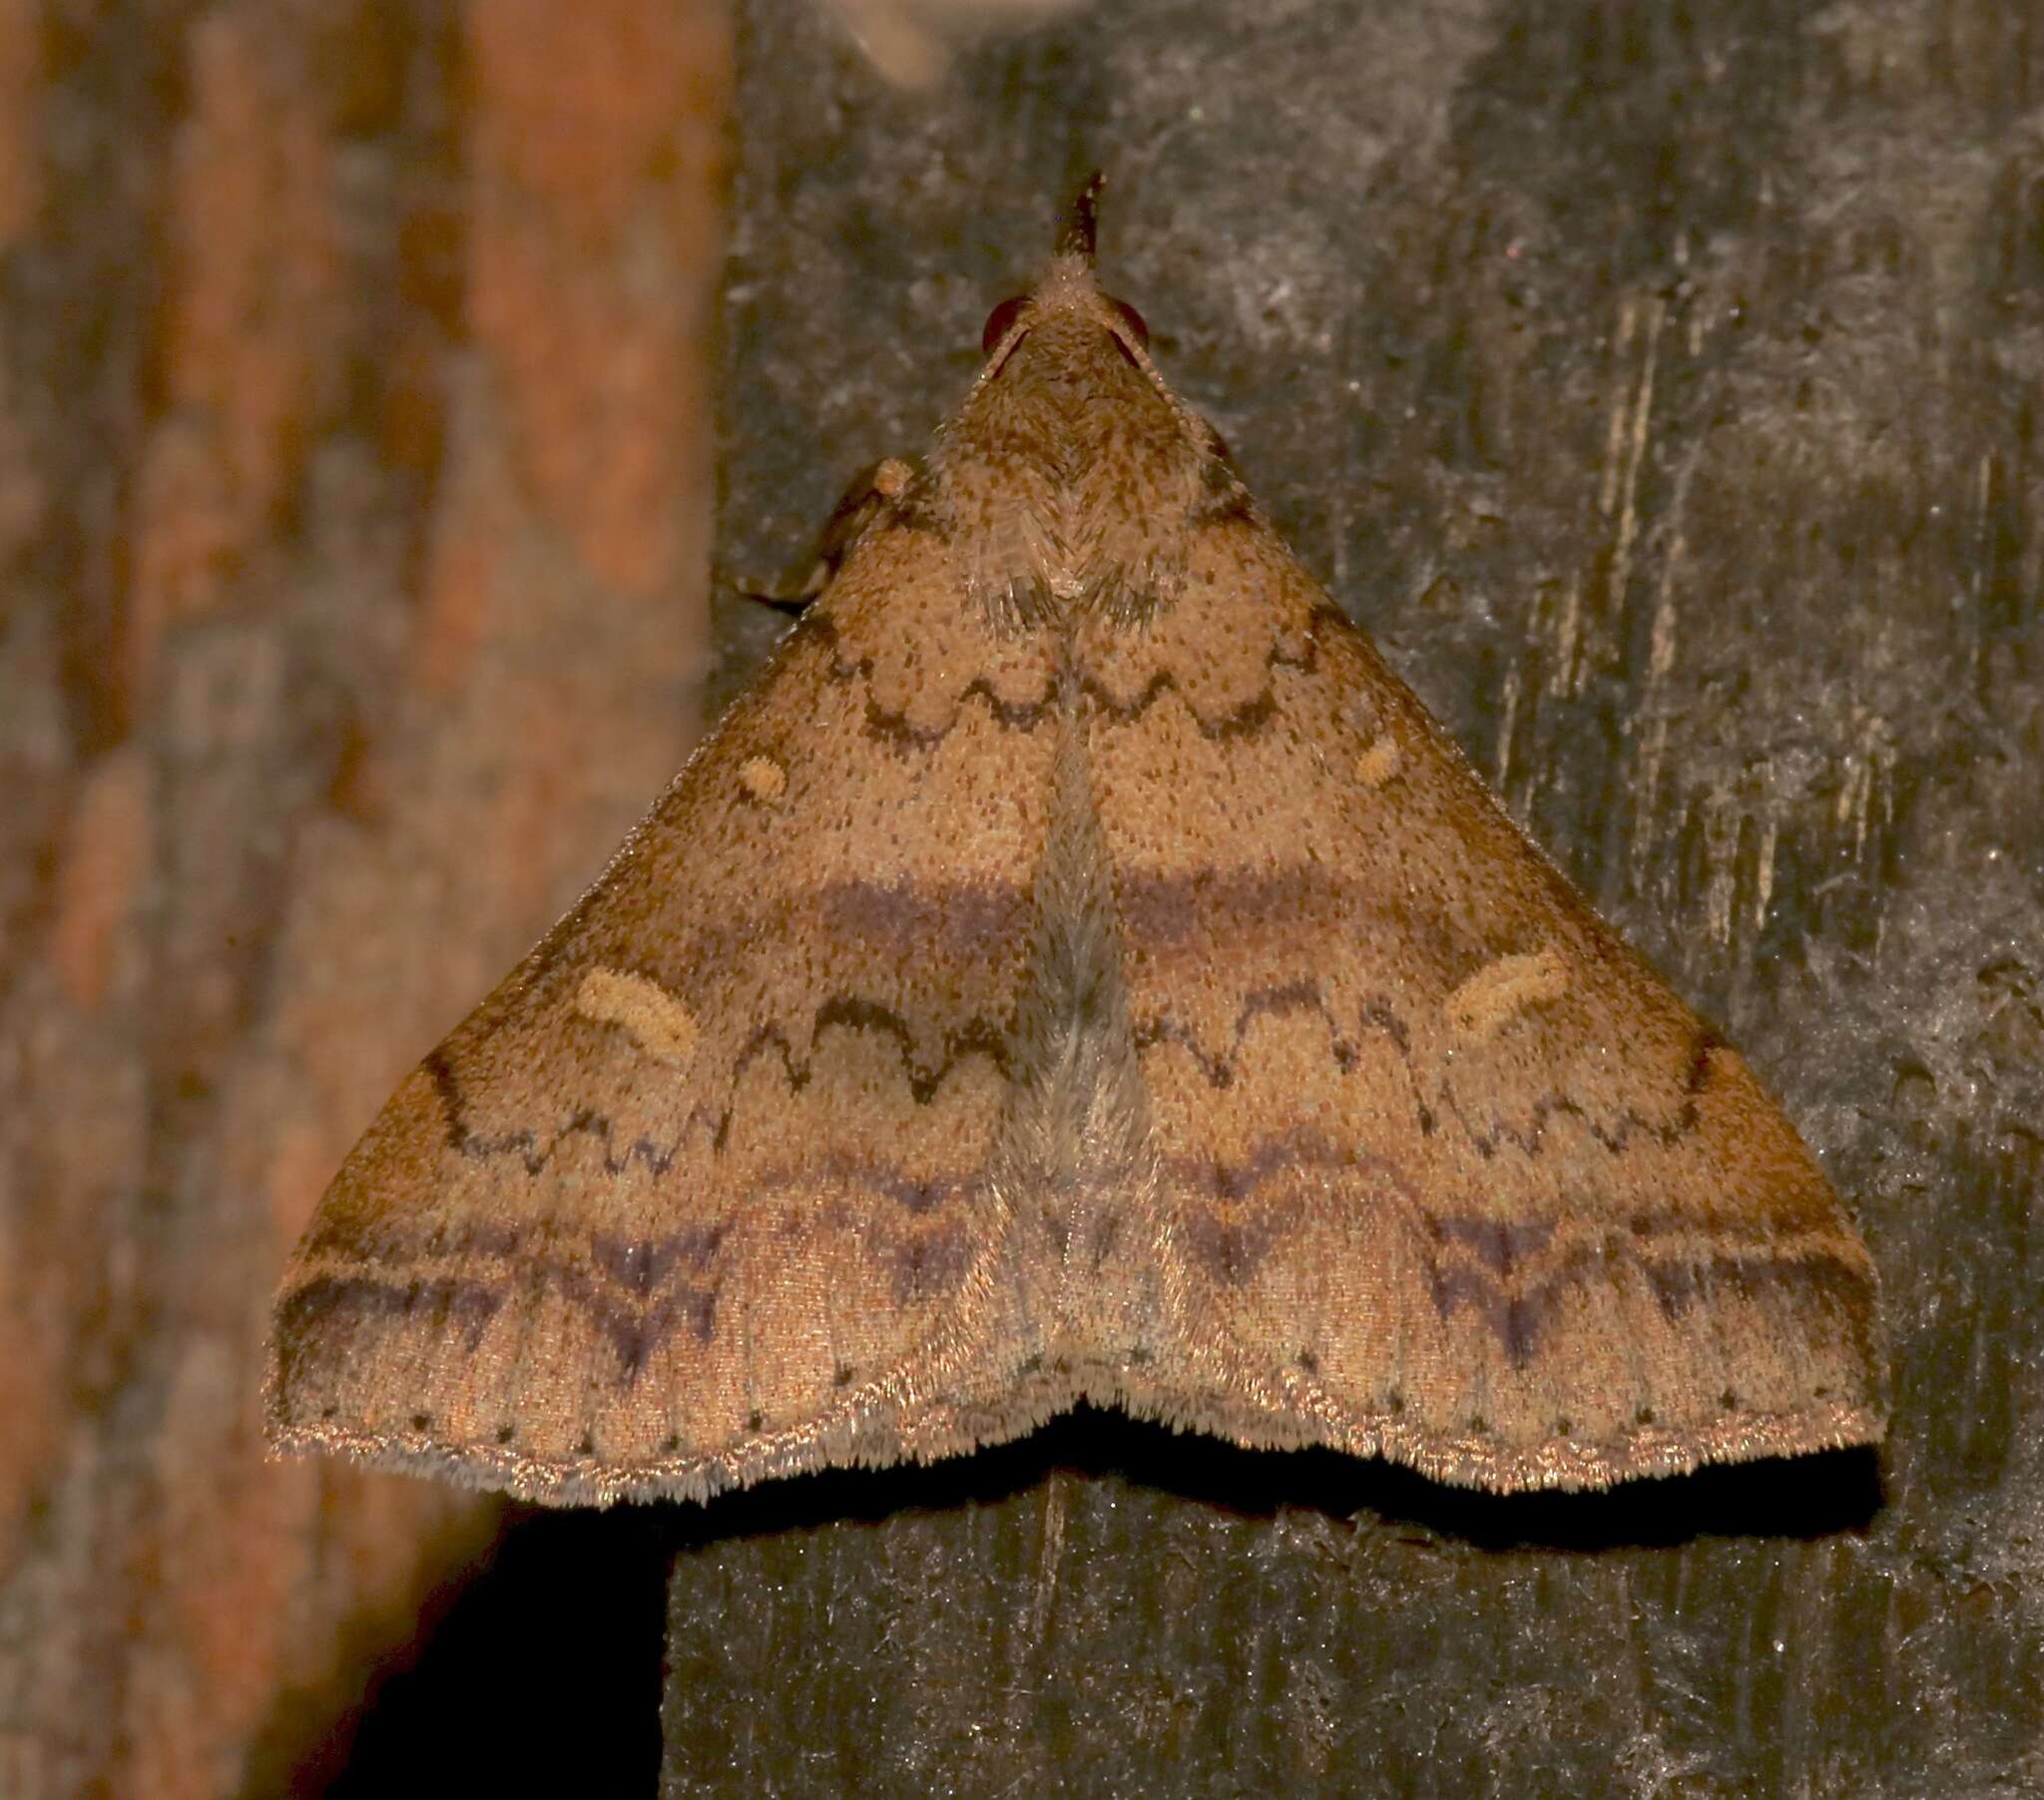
left=267, top=190, right=1882, bottom=1504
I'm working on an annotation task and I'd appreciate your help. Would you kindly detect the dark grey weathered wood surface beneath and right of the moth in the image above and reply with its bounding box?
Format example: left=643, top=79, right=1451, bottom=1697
left=665, top=0, right=2044, bottom=1796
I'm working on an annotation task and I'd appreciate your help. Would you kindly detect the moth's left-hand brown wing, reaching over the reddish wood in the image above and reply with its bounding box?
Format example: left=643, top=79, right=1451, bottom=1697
left=269, top=498, right=1053, bottom=1502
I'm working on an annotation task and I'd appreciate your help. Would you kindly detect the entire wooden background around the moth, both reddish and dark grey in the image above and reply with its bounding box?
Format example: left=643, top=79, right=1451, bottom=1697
left=0, top=0, right=2044, bottom=1800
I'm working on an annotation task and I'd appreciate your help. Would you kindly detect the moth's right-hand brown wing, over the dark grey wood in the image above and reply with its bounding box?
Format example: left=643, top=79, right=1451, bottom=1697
left=1085, top=507, right=1878, bottom=1488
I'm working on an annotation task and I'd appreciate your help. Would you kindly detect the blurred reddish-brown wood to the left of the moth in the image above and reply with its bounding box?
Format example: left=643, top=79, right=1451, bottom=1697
left=0, top=0, right=730, bottom=1800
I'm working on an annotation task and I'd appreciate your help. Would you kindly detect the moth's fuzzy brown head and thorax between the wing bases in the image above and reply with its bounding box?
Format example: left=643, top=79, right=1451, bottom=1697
left=930, top=271, right=1233, bottom=621
